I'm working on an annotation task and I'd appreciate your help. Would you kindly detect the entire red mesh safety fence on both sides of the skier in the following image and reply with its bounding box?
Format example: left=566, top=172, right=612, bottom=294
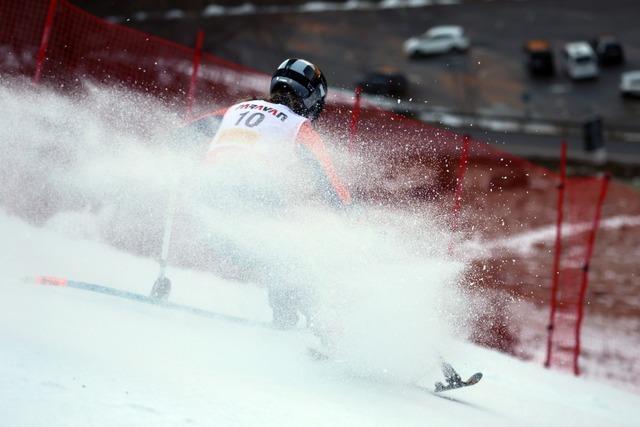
left=0, top=0, right=638, bottom=373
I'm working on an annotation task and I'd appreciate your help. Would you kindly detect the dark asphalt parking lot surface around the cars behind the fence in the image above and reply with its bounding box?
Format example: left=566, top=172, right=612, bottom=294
left=115, top=0, right=640, bottom=164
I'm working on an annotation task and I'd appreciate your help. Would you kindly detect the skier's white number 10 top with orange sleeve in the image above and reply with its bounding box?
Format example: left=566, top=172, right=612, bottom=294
left=189, top=100, right=351, bottom=204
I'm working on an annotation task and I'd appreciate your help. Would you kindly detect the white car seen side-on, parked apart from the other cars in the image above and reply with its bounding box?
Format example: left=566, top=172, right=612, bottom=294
left=404, top=25, right=469, bottom=56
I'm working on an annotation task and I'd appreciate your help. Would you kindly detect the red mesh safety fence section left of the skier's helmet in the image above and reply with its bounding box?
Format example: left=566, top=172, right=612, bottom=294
left=0, top=0, right=267, bottom=112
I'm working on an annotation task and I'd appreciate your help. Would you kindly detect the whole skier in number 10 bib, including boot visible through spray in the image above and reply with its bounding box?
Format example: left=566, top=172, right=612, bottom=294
left=152, top=58, right=351, bottom=329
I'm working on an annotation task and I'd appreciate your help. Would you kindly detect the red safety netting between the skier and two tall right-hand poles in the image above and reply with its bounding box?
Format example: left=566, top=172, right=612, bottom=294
left=340, top=100, right=557, bottom=238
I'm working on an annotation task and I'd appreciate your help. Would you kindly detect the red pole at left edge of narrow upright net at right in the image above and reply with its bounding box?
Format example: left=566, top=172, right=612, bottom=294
left=544, top=141, right=567, bottom=368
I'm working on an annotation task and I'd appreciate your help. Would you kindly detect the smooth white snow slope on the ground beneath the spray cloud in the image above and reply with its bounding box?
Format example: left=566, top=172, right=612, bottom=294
left=0, top=214, right=640, bottom=427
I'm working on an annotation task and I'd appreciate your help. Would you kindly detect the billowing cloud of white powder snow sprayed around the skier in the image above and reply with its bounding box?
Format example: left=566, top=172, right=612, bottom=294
left=0, top=76, right=466, bottom=382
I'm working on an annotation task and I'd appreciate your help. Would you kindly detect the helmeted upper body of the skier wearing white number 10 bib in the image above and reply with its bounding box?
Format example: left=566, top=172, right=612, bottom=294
left=201, top=59, right=351, bottom=205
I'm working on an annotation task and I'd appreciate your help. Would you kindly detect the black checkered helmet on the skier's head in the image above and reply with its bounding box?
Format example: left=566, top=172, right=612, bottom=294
left=270, top=58, right=327, bottom=120
